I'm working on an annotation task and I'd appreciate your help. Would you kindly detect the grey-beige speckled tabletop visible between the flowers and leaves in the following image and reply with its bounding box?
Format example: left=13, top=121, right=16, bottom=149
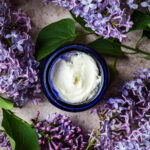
left=0, top=0, right=150, bottom=149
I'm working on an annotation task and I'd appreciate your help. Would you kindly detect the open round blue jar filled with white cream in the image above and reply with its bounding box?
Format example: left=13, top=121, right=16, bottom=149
left=42, top=45, right=109, bottom=112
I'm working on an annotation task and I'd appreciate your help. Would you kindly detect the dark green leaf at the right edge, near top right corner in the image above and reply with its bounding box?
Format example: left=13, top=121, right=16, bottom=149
left=131, top=11, right=150, bottom=31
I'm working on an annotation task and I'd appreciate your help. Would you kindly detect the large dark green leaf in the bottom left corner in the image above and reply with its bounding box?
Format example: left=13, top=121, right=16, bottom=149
left=2, top=109, right=40, bottom=150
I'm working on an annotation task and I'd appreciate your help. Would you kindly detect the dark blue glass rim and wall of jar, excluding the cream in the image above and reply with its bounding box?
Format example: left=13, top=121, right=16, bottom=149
left=42, top=45, right=109, bottom=112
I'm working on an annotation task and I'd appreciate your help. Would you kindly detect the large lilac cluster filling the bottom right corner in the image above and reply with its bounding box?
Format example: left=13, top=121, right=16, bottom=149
left=90, top=69, right=150, bottom=150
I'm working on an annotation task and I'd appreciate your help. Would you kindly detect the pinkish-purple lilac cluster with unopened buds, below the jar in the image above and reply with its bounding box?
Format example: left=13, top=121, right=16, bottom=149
left=33, top=112, right=87, bottom=150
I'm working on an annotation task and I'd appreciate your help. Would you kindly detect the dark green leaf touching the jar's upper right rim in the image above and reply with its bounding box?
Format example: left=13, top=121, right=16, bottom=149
left=89, top=38, right=124, bottom=56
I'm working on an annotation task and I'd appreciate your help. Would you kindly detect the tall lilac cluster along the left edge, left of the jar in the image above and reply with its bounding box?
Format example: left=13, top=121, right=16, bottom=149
left=0, top=0, right=41, bottom=106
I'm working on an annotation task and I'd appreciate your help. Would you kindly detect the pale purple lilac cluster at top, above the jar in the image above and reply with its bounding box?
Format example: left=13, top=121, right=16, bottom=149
left=44, top=0, right=133, bottom=41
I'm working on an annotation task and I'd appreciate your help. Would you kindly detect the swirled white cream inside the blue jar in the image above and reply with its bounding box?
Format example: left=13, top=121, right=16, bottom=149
left=51, top=52, right=101, bottom=103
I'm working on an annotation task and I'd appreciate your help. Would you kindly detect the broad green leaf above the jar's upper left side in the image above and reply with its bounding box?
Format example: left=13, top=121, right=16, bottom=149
left=36, top=19, right=76, bottom=60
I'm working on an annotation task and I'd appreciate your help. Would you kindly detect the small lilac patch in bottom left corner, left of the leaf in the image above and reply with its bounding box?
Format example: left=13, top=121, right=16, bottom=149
left=0, top=133, right=12, bottom=150
